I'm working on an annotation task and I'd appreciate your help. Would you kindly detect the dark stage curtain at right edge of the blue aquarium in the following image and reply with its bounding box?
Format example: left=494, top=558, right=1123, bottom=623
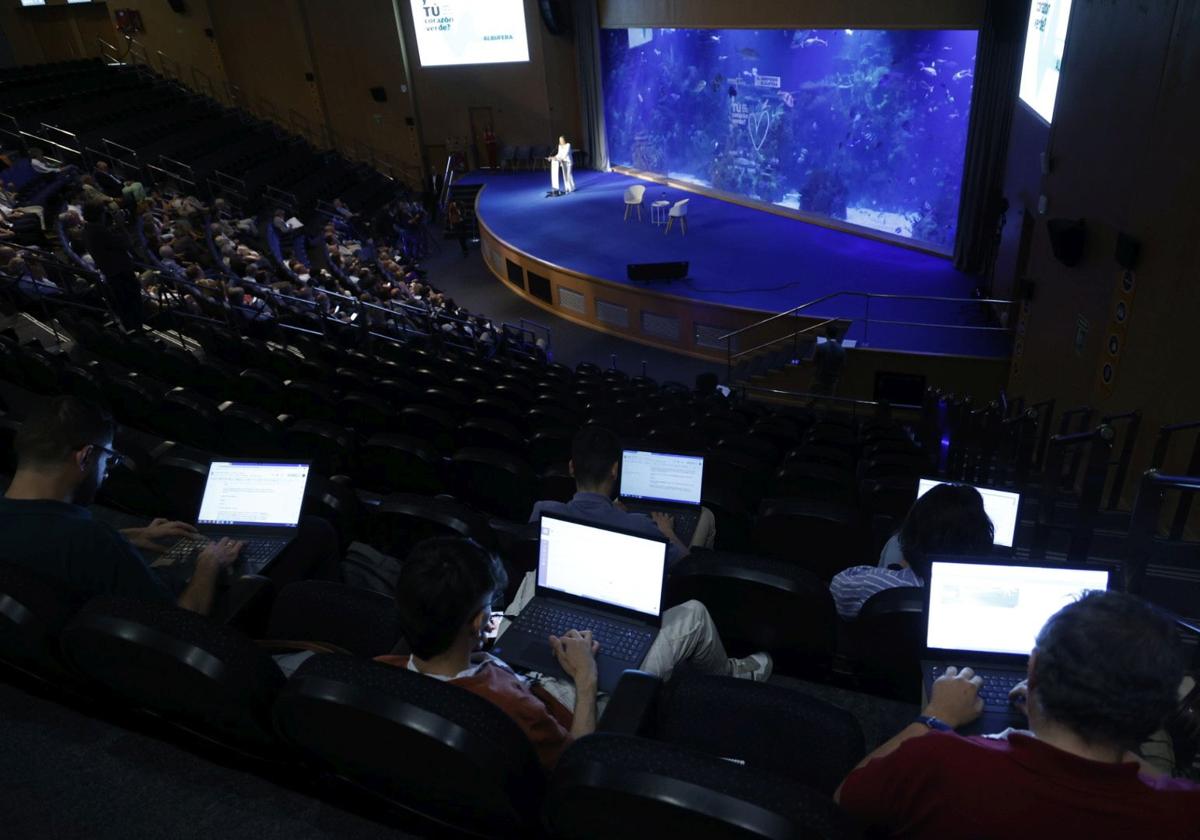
left=954, top=0, right=1030, bottom=274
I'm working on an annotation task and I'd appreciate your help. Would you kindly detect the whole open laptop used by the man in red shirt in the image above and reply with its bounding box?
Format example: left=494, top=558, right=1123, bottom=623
left=920, top=557, right=1110, bottom=734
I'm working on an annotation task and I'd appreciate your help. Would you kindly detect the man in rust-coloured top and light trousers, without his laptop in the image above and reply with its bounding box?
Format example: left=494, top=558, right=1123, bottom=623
left=379, top=538, right=772, bottom=769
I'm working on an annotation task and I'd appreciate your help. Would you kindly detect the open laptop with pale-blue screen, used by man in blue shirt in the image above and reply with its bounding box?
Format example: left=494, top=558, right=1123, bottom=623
left=618, top=449, right=704, bottom=545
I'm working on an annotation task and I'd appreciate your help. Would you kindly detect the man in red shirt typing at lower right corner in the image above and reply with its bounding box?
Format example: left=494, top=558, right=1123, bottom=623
left=835, top=592, right=1200, bottom=840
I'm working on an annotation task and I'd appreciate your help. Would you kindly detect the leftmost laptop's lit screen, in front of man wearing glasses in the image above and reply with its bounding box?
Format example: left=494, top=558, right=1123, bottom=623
left=197, top=461, right=308, bottom=528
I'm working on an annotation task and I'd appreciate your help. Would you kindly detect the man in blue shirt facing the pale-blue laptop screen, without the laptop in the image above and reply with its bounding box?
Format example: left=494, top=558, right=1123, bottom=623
left=529, top=426, right=716, bottom=566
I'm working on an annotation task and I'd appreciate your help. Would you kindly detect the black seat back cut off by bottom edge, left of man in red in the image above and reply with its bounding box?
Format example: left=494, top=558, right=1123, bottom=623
left=544, top=733, right=854, bottom=840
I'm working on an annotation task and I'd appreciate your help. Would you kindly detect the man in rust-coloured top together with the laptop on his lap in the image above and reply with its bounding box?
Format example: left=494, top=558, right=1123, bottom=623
left=379, top=535, right=772, bottom=769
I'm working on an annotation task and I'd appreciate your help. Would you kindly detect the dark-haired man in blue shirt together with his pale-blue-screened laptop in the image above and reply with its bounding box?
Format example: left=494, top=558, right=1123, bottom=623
left=529, top=426, right=716, bottom=568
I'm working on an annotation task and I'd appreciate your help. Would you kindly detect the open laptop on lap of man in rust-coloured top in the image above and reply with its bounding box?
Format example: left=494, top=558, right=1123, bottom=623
left=493, top=514, right=667, bottom=692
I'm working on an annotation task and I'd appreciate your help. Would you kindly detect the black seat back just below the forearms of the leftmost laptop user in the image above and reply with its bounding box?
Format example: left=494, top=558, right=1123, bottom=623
left=62, top=598, right=284, bottom=755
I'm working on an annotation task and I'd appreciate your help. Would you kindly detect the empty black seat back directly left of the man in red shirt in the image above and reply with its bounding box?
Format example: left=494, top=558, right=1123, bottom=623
left=655, top=670, right=866, bottom=796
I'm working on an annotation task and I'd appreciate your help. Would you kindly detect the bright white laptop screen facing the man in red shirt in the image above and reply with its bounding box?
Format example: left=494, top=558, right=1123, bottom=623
left=925, top=559, right=1109, bottom=656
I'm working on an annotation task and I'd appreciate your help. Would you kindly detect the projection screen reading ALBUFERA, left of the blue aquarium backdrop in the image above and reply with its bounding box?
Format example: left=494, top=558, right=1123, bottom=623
left=412, top=0, right=529, bottom=67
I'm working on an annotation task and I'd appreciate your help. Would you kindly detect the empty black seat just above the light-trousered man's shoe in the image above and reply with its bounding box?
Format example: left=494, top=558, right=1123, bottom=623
left=665, top=550, right=838, bottom=678
